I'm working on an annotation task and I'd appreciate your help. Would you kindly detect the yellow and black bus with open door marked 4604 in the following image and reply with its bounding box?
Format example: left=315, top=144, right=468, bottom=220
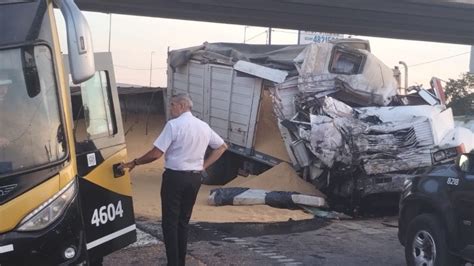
left=0, top=0, right=136, bottom=266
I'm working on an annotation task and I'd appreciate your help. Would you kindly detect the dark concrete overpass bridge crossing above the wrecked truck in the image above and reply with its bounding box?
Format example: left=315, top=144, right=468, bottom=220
left=76, top=0, right=474, bottom=45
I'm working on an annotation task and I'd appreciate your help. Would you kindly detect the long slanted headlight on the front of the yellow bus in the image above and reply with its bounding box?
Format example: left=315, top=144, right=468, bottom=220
left=17, top=180, right=76, bottom=231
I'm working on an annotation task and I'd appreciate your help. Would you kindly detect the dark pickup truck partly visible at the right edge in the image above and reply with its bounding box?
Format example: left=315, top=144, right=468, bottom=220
left=398, top=151, right=474, bottom=265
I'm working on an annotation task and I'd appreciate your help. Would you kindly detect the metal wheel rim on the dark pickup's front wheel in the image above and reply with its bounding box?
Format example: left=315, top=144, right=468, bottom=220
left=412, top=230, right=436, bottom=266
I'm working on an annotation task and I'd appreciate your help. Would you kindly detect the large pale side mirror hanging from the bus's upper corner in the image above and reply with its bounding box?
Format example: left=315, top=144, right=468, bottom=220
left=54, top=0, right=95, bottom=84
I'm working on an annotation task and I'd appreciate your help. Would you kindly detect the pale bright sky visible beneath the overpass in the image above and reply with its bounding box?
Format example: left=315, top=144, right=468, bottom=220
left=56, top=10, right=471, bottom=87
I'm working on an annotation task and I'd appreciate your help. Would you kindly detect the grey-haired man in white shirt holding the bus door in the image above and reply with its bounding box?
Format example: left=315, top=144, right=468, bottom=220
left=122, top=94, right=227, bottom=265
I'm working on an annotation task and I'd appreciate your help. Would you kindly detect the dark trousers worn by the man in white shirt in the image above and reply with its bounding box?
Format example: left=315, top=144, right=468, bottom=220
left=161, top=169, right=201, bottom=266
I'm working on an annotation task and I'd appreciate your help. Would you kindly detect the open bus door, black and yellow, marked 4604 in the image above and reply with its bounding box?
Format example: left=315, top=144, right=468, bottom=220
left=65, top=53, right=136, bottom=258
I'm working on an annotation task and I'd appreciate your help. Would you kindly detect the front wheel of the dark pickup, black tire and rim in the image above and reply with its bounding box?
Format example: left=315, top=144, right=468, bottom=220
left=405, top=214, right=461, bottom=266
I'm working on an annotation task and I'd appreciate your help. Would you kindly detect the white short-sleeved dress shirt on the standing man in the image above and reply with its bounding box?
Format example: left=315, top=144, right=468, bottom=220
left=153, top=112, right=224, bottom=171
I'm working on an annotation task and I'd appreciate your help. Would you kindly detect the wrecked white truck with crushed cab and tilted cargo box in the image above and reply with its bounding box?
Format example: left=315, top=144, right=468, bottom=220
left=164, top=39, right=474, bottom=208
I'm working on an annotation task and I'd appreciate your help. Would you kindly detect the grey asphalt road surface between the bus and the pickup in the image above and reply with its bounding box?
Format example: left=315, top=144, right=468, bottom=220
left=104, top=217, right=405, bottom=266
